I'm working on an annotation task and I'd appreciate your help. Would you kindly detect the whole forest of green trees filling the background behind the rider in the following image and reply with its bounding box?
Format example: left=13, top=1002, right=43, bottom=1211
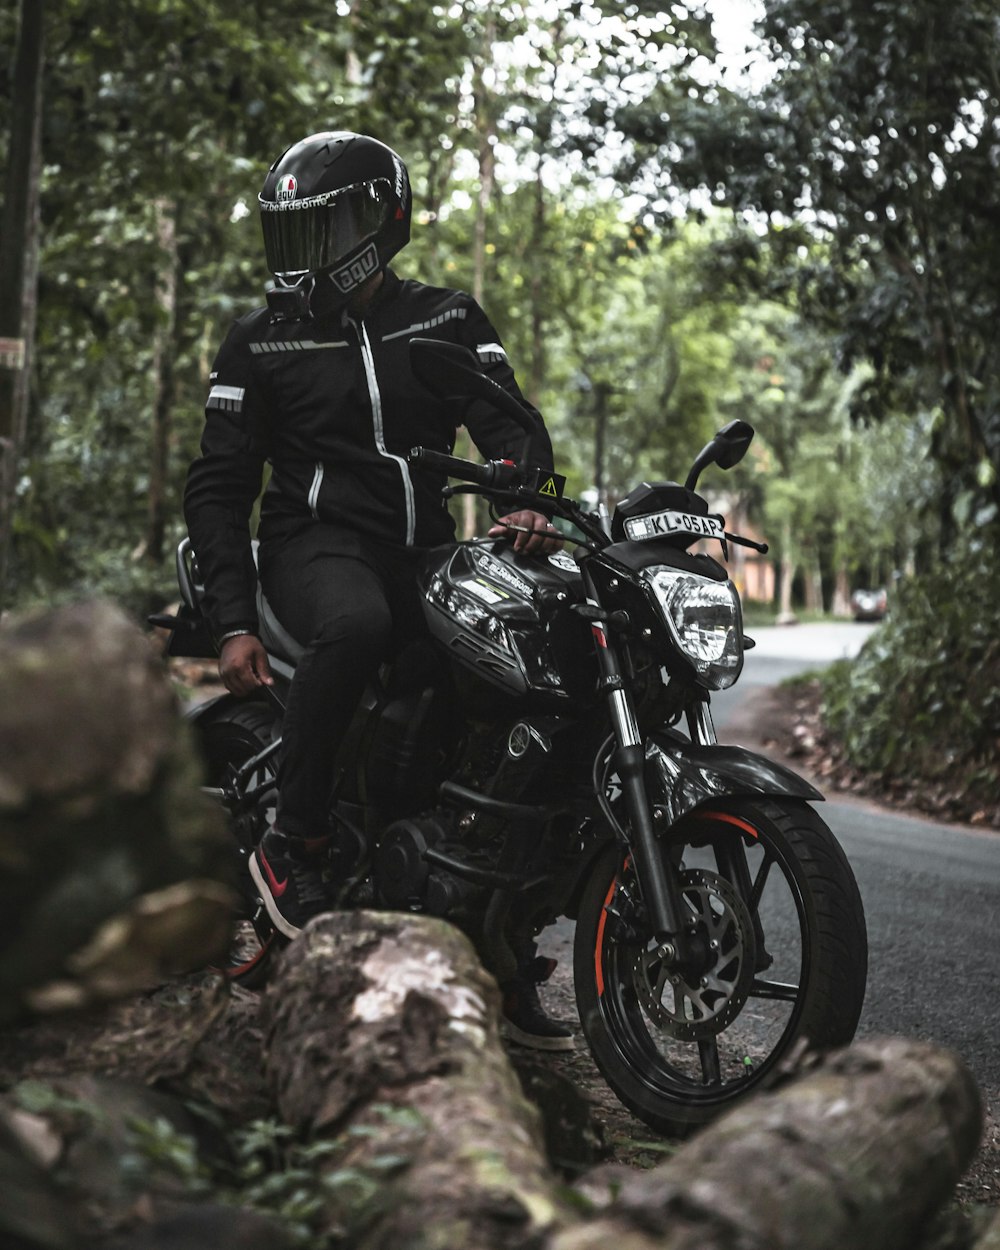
left=0, top=0, right=1000, bottom=798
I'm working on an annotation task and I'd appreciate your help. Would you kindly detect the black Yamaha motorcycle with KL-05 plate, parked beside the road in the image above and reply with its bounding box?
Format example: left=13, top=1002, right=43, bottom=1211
left=159, top=339, right=868, bottom=1135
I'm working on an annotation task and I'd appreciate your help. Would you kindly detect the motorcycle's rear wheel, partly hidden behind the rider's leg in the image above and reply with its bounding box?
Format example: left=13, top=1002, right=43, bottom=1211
left=198, top=704, right=285, bottom=989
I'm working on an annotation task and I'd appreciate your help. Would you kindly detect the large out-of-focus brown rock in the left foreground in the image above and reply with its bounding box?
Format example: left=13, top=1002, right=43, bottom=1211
left=0, top=601, right=233, bottom=1020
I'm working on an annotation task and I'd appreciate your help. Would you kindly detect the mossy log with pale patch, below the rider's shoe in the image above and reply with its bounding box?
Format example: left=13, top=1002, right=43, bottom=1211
left=265, top=913, right=573, bottom=1250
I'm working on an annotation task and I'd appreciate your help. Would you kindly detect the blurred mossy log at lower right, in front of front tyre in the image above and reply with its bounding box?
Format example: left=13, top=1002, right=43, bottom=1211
left=551, top=1038, right=983, bottom=1250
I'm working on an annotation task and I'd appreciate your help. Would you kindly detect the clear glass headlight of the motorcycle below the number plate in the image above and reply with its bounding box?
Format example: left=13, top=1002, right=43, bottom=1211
left=643, top=565, right=743, bottom=690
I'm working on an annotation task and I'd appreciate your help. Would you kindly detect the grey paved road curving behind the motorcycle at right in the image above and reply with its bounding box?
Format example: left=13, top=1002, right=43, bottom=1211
left=713, top=624, right=1000, bottom=1114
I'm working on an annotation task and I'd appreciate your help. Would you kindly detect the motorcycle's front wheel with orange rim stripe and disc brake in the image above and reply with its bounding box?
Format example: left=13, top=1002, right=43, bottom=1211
left=574, top=799, right=868, bottom=1135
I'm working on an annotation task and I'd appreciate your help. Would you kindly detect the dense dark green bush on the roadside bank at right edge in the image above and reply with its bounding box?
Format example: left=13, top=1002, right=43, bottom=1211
left=823, top=529, right=1000, bottom=810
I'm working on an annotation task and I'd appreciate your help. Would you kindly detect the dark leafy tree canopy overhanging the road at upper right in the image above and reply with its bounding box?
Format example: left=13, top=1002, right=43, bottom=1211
left=650, top=0, right=1000, bottom=527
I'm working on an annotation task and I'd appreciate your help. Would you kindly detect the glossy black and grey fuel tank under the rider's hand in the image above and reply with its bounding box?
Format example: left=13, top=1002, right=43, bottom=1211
left=420, top=539, right=596, bottom=704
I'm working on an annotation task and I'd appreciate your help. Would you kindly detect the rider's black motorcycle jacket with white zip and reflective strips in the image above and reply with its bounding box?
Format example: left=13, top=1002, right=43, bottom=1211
left=184, top=270, right=553, bottom=639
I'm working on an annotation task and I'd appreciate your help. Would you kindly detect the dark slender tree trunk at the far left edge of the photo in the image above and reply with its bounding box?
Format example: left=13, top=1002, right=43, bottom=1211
left=0, top=0, right=45, bottom=611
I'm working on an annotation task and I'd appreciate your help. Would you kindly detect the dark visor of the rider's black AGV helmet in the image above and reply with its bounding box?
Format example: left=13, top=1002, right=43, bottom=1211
left=259, top=178, right=396, bottom=280
